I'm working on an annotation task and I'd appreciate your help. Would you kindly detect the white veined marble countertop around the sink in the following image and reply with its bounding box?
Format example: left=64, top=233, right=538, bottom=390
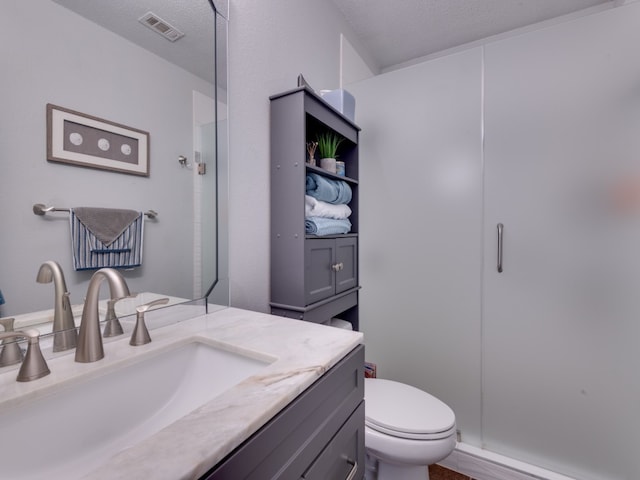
left=0, top=306, right=363, bottom=480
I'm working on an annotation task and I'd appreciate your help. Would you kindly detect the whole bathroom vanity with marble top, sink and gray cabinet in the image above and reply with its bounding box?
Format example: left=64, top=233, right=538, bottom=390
left=0, top=305, right=364, bottom=480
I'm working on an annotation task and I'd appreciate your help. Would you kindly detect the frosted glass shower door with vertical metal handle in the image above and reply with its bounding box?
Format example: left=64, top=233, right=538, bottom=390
left=482, top=4, right=640, bottom=480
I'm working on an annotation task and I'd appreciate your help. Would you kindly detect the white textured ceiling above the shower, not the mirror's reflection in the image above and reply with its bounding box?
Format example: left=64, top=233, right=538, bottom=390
left=332, top=0, right=613, bottom=71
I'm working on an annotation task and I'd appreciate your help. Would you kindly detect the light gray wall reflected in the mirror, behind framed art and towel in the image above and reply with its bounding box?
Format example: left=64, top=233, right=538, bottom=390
left=0, top=0, right=213, bottom=315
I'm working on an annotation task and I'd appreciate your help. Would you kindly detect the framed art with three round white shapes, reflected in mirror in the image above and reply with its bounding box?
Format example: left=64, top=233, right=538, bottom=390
left=47, top=103, right=149, bottom=177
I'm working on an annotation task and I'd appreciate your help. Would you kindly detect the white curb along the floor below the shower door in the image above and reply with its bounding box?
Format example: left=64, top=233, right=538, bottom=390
left=438, top=443, right=575, bottom=480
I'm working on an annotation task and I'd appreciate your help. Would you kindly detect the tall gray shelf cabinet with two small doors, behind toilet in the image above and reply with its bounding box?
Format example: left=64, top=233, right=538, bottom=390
left=270, top=87, right=360, bottom=330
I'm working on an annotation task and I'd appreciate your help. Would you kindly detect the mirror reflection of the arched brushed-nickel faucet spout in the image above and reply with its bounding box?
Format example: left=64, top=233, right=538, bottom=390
left=36, top=261, right=78, bottom=352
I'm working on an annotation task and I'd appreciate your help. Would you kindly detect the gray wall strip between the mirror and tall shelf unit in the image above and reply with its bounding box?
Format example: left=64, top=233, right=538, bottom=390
left=228, top=0, right=376, bottom=312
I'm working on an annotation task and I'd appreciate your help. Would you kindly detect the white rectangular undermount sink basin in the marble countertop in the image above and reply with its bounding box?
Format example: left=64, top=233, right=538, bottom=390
left=0, top=339, right=275, bottom=479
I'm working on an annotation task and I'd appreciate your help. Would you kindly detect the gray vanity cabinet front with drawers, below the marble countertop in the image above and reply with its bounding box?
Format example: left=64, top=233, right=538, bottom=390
left=201, top=345, right=365, bottom=480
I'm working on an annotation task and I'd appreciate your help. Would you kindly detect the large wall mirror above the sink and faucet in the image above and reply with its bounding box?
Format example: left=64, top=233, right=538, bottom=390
left=0, top=0, right=228, bottom=334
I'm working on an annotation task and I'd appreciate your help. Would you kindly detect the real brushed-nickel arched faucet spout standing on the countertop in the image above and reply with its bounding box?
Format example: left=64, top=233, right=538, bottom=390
left=76, top=268, right=131, bottom=363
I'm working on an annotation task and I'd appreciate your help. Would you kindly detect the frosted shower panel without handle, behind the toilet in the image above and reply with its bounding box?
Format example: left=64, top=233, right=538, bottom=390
left=347, top=49, right=482, bottom=446
